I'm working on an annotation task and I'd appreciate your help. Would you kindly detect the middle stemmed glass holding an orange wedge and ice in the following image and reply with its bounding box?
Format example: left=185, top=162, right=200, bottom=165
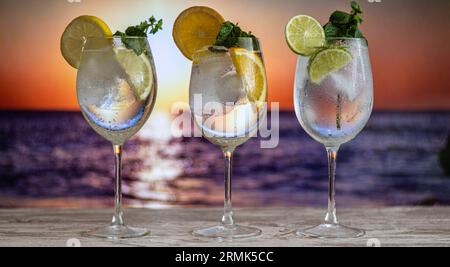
left=189, top=38, right=267, bottom=239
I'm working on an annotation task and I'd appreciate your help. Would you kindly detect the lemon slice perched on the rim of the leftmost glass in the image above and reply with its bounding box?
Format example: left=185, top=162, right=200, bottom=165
left=61, top=16, right=112, bottom=69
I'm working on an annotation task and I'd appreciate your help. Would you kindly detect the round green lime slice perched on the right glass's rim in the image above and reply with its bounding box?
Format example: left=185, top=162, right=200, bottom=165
left=285, top=15, right=325, bottom=56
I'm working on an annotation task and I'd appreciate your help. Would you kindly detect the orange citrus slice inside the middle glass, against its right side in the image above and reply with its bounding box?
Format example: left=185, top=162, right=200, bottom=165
left=230, top=48, right=267, bottom=106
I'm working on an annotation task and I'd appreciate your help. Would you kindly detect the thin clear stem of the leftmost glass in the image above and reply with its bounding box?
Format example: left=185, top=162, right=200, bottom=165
left=111, top=145, right=124, bottom=225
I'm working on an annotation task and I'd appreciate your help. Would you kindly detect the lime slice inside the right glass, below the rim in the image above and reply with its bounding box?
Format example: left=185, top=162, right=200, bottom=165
left=308, top=48, right=352, bottom=84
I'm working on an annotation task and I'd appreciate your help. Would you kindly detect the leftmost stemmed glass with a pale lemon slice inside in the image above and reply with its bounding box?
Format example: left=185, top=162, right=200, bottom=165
left=77, top=37, right=157, bottom=239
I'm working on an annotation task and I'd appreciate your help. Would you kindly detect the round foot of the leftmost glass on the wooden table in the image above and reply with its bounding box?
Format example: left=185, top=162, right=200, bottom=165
left=83, top=225, right=150, bottom=239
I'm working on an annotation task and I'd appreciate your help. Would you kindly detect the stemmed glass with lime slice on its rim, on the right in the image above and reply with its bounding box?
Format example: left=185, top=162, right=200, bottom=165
left=294, top=38, right=373, bottom=238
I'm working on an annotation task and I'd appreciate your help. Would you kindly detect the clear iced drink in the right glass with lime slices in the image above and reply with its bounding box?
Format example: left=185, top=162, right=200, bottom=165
left=294, top=41, right=373, bottom=146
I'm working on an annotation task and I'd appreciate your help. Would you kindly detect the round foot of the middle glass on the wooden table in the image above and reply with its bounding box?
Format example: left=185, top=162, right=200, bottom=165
left=192, top=224, right=262, bottom=239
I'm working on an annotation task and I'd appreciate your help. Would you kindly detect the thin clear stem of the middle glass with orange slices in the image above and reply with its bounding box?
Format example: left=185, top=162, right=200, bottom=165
left=222, top=148, right=234, bottom=226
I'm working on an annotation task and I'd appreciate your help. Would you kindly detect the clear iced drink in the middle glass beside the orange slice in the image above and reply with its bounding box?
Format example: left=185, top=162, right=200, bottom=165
left=190, top=48, right=265, bottom=147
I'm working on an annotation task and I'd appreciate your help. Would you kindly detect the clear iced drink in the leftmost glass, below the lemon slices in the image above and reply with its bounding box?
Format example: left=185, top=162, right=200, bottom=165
left=77, top=41, right=156, bottom=144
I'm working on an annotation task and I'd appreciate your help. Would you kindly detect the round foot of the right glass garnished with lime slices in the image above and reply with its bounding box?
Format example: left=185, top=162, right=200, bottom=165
left=297, top=223, right=365, bottom=238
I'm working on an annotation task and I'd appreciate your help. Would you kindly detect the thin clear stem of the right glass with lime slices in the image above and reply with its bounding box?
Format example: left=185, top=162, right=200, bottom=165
left=325, top=146, right=339, bottom=224
